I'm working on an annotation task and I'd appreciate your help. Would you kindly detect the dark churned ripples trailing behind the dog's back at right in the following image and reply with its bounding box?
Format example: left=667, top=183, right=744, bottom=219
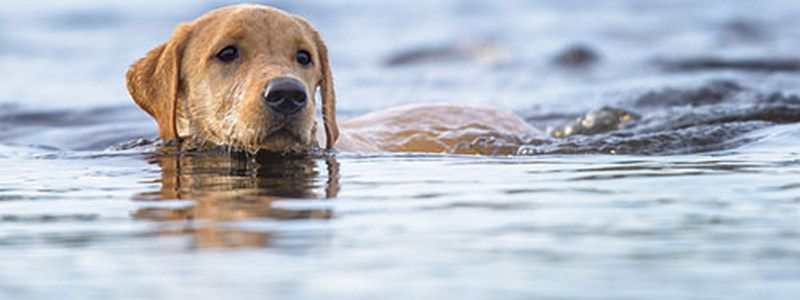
left=451, top=81, right=800, bottom=155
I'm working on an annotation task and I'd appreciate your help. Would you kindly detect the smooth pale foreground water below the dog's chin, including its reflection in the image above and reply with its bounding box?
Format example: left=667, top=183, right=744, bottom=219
left=0, top=138, right=800, bottom=299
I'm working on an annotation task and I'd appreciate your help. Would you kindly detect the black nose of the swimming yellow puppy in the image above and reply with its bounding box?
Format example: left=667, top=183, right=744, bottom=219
left=263, top=78, right=308, bottom=116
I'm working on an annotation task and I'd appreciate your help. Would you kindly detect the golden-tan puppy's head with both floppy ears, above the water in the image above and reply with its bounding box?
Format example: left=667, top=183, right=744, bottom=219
left=127, top=5, right=339, bottom=151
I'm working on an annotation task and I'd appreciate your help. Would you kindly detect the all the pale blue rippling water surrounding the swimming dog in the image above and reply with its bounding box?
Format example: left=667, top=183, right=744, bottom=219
left=0, top=0, right=800, bottom=299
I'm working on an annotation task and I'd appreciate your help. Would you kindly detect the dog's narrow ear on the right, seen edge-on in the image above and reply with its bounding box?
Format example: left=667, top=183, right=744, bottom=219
left=296, top=17, right=339, bottom=149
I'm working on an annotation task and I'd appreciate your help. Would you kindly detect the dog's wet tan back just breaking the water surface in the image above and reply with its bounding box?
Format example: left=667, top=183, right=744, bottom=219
left=332, top=104, right=539, bottom=154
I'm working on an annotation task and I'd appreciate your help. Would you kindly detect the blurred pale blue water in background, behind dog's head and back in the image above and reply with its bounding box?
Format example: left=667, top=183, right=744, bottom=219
left=0, top=0, right=800, bottom=115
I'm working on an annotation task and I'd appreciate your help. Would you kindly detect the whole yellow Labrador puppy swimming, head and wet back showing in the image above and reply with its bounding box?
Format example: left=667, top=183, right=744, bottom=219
left=126, top=4, right=539, bottom=153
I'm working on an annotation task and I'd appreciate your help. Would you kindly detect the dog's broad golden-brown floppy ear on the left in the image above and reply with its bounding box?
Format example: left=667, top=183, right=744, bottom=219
left=126, top=24, right=190, bottom=140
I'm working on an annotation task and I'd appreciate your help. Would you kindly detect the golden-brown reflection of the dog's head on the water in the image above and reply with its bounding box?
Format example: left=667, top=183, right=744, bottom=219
left=133, top=149, right=339, bottom=249
